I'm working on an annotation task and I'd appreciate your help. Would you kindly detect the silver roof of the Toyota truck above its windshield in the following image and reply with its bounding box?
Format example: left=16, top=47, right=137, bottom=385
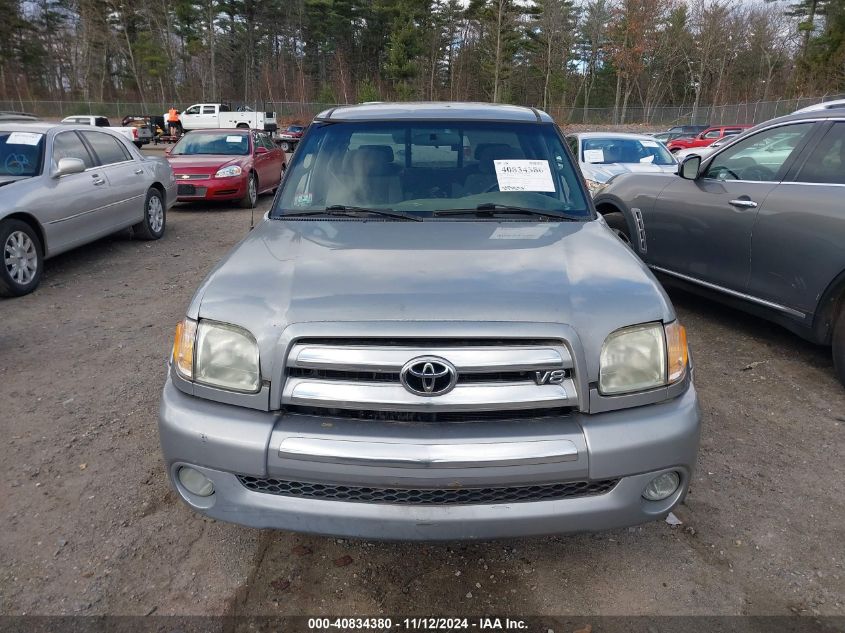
left=314, top=101, right=553, bottom=123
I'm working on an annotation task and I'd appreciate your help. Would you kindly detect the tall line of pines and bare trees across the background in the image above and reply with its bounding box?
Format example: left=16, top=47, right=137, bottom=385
left=0, top=0, right=845, bottom=121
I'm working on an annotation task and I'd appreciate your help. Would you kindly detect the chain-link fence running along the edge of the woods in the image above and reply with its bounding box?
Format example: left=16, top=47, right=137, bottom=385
left=0, top=94, right=845, bottom=129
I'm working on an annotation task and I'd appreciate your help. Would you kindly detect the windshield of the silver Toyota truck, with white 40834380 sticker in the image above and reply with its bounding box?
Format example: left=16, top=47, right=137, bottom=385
left=272, top=121, right=592, bottom=219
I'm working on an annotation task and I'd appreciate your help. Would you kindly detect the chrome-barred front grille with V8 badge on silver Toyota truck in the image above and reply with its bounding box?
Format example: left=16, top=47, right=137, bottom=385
left=282, top=338, right=578, bottom=419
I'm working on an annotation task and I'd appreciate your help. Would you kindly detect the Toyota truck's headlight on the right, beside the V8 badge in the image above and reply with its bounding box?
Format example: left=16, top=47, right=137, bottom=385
left=599, top=321, right=688, bottom=395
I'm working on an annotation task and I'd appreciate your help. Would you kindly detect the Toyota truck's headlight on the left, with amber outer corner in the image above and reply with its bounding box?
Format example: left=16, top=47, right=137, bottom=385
left=173, top=319, right=261, bottom=393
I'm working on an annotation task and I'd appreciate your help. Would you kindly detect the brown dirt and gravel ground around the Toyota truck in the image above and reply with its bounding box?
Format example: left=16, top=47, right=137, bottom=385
left=0, top=172, right=845, bottom=615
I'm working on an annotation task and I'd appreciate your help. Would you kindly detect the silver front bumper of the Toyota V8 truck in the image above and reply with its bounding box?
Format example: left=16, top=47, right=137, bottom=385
left=159, top=378, right=699, bottom=540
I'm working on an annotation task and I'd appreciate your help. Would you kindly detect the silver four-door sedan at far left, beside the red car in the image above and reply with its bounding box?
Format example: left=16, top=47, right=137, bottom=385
left=0, top=123, right=176, bottom=297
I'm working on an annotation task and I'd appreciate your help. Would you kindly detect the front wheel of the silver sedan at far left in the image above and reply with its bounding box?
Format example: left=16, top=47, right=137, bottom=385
left=0, top=219, right=44, bottom=297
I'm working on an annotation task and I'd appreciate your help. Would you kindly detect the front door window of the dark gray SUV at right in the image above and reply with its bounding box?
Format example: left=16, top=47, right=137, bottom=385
left=704, top=123, right=813, bottom=182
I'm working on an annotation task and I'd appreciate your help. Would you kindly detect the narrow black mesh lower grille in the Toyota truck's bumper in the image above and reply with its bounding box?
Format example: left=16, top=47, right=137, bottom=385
left=238, top=475, right=619, bottom=505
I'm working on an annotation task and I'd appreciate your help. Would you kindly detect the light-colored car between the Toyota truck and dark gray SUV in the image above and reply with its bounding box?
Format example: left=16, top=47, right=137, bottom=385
left=566, top=132, right=678, bottom=194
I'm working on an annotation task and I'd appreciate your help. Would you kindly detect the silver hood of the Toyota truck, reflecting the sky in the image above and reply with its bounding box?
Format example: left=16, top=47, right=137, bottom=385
left=188, top=220, right=674, bottom=374
